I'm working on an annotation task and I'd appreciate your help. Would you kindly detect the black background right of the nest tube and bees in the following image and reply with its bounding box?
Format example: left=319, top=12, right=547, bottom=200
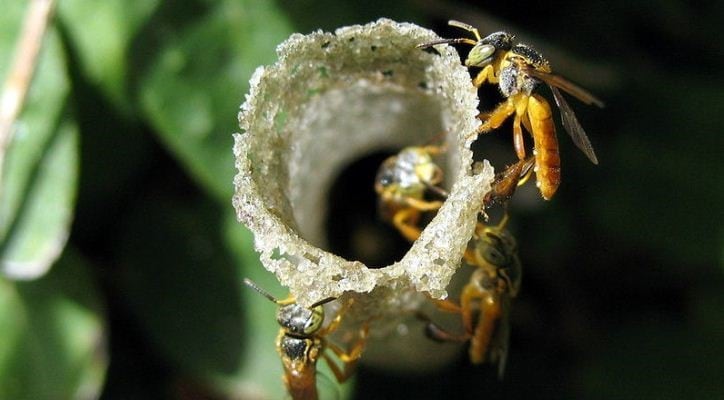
left=302, top=1, right=724, bottom=399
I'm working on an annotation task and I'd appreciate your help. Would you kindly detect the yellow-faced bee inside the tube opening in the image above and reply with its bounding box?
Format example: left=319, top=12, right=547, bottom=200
left=375, top=145, right=447, bottom=242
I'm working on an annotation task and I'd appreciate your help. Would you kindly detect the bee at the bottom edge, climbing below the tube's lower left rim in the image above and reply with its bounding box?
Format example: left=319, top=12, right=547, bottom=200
left=244, top=279, right=368, bottom=400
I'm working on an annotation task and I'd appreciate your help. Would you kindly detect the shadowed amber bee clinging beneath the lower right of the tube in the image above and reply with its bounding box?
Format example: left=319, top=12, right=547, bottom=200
left=418, top=215, right=522, bottom=378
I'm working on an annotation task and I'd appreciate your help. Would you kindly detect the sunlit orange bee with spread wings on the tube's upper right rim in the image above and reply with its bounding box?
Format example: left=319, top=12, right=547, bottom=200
left=418, top=21, right=603, bottom=200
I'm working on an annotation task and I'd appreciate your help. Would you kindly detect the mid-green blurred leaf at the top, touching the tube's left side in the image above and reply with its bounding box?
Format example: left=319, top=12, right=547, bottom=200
left=138, top=0, right=291, bottom=204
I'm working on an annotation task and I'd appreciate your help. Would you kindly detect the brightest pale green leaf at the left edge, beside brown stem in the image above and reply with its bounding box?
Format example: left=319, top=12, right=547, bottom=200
left=0, top=2, right=78, bottom=279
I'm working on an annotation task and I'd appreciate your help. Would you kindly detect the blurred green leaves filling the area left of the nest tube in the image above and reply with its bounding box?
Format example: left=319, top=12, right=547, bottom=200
left=0, top=0, right=291, bottom=399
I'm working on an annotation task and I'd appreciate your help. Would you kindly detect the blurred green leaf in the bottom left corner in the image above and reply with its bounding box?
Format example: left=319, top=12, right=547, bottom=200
left=0, top=248, right=107, bottom=400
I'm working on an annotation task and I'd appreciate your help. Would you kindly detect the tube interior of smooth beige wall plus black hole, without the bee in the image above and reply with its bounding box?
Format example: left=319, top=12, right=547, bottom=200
left=288, top=84, right=459, bottom=268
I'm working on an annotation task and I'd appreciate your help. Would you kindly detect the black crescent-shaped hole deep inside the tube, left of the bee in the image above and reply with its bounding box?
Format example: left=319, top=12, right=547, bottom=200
left=325, top=150, right=422, bottom=268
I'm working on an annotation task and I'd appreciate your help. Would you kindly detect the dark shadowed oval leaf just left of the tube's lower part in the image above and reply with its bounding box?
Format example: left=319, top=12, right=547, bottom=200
left=111, top=195, right=243, bottom=390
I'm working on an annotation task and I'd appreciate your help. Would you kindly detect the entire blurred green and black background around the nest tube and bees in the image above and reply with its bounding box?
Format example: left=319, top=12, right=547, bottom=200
left=0, top=0, right=724, bottom=399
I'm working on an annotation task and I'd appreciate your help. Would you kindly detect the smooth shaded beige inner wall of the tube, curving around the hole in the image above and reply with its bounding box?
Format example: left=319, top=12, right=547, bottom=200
left=290, top=86, right=444, bottom=253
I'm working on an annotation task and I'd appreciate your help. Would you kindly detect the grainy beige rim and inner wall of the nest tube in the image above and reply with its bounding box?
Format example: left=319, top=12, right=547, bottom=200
left=233, top=19, right=493, bottom=368
